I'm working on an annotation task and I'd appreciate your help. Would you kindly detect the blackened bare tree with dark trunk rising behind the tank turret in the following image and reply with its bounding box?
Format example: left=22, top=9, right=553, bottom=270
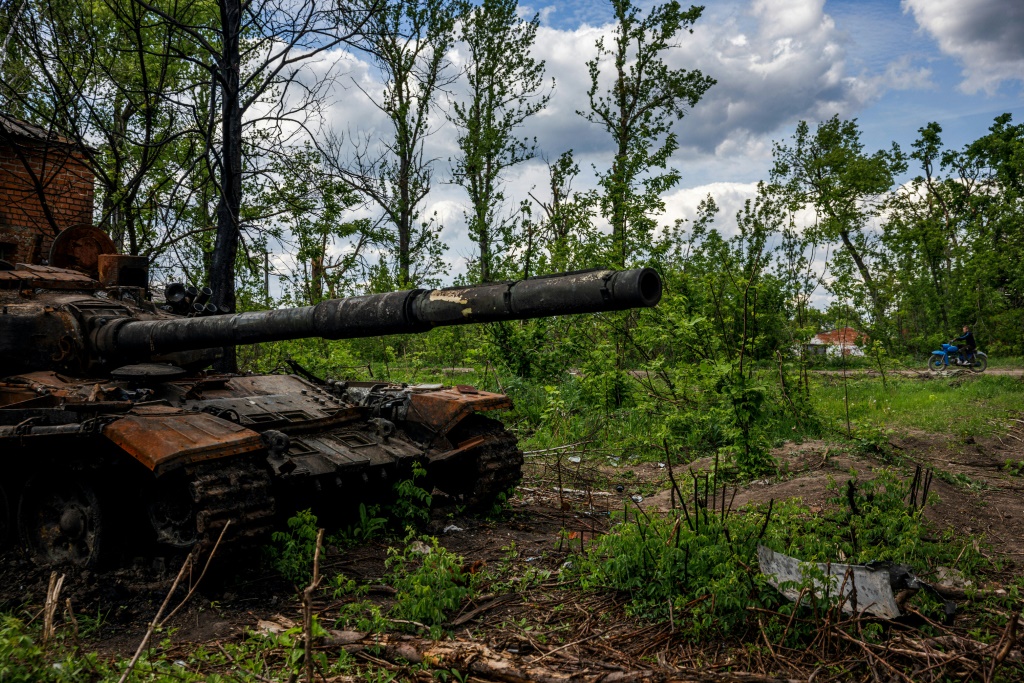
left=126, top=0, right=378, bottom=371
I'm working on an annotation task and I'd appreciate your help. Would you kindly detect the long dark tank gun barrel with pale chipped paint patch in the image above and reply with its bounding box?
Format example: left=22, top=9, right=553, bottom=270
left=92, top=268, right=662, bottom=358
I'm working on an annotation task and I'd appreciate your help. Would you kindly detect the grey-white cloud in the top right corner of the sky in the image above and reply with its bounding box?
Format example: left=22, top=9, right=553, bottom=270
left=903, top=0, right=1024, bottom=94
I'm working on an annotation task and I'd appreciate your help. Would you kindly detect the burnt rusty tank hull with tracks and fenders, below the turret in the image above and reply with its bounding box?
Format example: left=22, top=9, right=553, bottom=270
left=0, top=373, right=522, bottom=566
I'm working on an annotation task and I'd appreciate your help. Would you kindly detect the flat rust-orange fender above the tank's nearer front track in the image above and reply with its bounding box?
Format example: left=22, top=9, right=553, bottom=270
left=103, top=413, right=264, bottom=476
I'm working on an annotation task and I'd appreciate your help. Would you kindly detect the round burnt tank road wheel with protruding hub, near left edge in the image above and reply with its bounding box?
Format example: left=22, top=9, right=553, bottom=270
left=17, top=475, right=103, bottom=567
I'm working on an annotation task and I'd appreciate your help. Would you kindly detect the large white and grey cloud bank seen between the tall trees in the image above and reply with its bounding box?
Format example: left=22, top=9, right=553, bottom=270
left=292, top=0, right=931, bottom=282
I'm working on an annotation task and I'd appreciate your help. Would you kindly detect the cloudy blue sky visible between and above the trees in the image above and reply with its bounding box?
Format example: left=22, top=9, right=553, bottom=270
left=294, top=0, right=1024, bottom=286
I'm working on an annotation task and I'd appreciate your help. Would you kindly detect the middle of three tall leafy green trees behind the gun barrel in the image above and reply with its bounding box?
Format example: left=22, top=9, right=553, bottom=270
left=449, top=0, right=554, bottom=282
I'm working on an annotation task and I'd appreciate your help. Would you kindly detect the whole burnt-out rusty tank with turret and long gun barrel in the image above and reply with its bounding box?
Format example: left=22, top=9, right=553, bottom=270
left=0, top=228, right=662, bottom=566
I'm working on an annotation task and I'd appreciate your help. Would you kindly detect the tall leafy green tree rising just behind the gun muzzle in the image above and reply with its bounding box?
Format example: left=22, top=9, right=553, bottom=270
left=578, top=0, right=715, bottom=268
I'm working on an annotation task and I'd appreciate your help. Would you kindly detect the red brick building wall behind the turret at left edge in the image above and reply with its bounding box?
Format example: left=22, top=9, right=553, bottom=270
left=0, top=137, right=93, bottom=263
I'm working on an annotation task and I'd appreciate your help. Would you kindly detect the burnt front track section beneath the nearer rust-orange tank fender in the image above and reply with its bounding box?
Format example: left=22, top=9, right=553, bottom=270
left=188, top=457, right=274, bottom=555
